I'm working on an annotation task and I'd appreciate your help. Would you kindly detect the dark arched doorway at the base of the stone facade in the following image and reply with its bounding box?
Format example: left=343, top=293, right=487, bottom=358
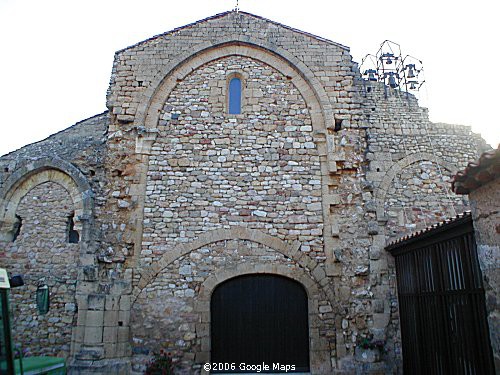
left=210, top=274, right=309, bottom=373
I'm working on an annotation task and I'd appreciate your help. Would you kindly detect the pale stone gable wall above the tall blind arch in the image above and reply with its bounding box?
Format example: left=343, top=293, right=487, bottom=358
left=107, top=12, right=352, bottom=122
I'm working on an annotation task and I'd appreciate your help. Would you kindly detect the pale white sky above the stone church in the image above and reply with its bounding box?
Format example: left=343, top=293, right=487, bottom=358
left=0, top=0, right=500, bottom=155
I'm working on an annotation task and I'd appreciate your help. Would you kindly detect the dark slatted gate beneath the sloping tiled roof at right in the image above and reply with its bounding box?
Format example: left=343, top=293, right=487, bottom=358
left=387, top=215, right=494, bottom=375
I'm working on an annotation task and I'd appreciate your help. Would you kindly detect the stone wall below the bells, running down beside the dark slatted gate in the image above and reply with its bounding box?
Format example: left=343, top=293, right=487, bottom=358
left=358, top=81, right=487, bottom=372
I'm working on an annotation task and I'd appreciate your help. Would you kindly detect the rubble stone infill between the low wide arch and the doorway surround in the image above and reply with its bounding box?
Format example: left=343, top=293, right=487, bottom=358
left=131, top=240, right=335, bottom=374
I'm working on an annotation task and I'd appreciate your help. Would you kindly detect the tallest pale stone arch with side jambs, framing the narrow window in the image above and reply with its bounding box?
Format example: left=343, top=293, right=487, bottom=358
left=129, top=40, right=336, bottom=265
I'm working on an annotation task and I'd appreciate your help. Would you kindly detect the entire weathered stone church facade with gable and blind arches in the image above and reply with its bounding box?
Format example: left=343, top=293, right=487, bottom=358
left=0, top=12, right=486, bottom=374
